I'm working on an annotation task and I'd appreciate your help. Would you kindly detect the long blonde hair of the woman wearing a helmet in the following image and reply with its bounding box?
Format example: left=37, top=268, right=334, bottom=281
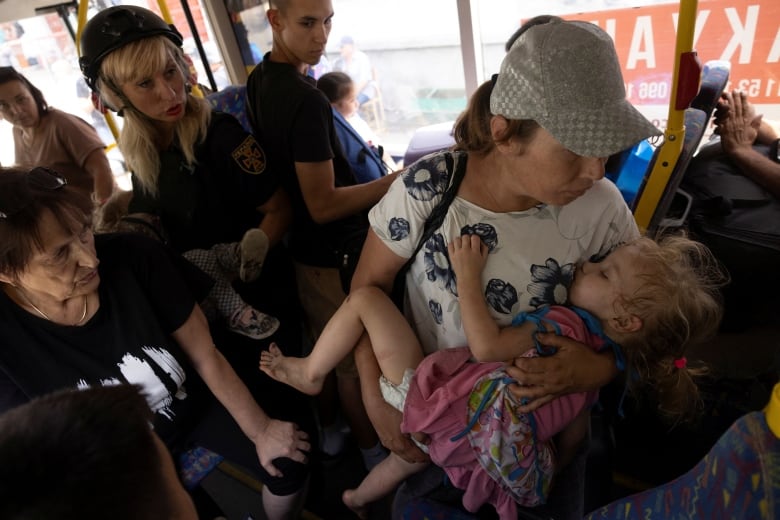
left=97, top=36, right=211, bottom=195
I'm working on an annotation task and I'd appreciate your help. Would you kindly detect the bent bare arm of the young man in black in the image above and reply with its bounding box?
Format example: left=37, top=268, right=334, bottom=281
left=295, top=160, right=396, bottom=224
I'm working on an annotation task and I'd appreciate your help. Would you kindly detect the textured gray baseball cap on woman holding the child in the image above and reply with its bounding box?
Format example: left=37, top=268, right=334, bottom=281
left=490, top=21, right=661, bottom=157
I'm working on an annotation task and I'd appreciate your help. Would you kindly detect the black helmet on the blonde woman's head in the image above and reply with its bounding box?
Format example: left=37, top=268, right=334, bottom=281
left=79, top=5, right=182, bottom=90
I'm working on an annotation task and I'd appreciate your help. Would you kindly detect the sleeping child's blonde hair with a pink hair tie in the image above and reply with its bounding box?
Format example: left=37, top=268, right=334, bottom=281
left=620, top=233, right=728, bottom=419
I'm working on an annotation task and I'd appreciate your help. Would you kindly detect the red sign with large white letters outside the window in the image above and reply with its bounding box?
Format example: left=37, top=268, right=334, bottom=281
left=565, top=0, right=780, bottom=105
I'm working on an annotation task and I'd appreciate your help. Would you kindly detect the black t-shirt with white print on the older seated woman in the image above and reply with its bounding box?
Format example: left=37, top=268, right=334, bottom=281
left=0, top=234, right=210, bottom=446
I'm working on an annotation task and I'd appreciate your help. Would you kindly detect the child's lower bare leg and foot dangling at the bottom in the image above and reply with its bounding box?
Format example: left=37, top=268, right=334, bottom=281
left=341, top=453, right=428, bottom=518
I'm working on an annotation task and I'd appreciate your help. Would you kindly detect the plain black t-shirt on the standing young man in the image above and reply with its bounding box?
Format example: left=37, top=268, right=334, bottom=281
left=247, top=53, right=367, bottom=267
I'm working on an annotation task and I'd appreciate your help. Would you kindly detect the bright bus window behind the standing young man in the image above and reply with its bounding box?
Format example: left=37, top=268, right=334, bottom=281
left=232, top=0, right=466, bottom=155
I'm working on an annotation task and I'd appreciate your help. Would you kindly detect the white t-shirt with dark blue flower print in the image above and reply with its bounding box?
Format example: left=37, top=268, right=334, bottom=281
left=370, top=151, right=639, bottom=354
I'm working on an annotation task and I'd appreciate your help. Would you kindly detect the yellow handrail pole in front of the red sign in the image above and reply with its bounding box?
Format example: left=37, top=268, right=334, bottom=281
left=634, top=0, right=698, bottom=232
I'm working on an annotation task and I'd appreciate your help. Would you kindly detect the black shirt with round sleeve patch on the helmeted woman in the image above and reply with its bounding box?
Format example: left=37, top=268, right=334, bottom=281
left=130, top=112, right=280, bottom=252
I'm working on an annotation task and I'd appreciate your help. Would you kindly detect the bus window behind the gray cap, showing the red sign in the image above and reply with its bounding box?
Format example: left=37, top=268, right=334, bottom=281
left=474, top=0, right=780, bottom=134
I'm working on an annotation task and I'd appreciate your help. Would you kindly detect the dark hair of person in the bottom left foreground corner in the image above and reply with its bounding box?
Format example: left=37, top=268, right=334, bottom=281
left=0, top=385, right=171, bottom=520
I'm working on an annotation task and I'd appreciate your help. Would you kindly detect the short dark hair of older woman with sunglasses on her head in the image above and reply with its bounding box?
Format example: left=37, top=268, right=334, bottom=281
left=0, top=167, right=94, bottom=276
